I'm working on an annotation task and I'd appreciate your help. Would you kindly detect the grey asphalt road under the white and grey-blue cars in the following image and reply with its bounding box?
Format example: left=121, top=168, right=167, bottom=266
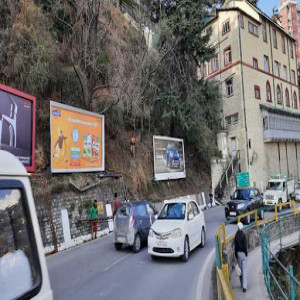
left=47, top=207, right=231, bottom=300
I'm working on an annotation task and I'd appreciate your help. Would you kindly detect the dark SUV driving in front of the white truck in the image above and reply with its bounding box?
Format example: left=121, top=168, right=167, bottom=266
left=225, top=187, right=264, bottom=224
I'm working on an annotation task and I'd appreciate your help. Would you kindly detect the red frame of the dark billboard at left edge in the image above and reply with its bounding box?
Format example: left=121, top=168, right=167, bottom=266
left=0, top=83, right=36, bottom=173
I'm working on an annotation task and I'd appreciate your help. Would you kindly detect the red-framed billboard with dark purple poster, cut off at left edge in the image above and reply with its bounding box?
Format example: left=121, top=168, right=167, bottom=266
left=0, top=84, right=36, bottom=172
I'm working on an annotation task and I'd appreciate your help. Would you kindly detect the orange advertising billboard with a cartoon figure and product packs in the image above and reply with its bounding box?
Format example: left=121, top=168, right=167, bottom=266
left=50, top=101, right=105, bottom=173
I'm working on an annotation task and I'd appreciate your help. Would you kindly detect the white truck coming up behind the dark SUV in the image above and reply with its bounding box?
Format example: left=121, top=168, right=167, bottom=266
left=263, top=175, right=295, bottom=211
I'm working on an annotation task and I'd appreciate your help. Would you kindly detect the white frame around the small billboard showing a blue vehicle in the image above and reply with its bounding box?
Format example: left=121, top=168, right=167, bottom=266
left=153, top=135, right=186, bottom=181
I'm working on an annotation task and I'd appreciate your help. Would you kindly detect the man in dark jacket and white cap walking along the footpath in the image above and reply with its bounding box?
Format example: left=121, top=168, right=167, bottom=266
left=234, top=222, right=248, bottom=293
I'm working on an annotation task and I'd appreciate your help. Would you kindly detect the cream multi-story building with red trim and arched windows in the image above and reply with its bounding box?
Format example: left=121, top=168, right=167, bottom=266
left=205, top=0, right=300, bottom=191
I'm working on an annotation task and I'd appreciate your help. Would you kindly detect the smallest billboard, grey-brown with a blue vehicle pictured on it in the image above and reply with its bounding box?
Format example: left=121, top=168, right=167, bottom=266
left=153, top=136, right=186, bottom=180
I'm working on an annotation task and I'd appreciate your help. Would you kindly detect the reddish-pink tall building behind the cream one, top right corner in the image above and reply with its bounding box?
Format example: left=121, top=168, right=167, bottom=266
left=279, top=0, right=300, bottom=59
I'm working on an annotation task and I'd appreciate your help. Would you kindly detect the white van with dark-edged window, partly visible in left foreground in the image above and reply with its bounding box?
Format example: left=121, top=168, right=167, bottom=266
left=0, top=150, right=53, bottom=300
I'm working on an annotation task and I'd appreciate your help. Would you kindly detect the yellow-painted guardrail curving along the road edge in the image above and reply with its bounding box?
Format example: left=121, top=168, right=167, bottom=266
left=215, top=201, right=300, bottom=300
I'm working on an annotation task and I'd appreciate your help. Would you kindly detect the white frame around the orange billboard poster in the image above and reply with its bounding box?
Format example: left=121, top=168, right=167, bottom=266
left=50, top=100, right=105, bottom=173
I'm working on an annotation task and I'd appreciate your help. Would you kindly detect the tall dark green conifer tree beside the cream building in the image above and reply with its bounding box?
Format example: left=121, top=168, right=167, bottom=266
left=150, top=0, right=220, bottom=162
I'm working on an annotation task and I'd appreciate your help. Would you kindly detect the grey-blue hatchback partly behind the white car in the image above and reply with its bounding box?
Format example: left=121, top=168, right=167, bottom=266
left=114, top=200, right=156, bottom=253
